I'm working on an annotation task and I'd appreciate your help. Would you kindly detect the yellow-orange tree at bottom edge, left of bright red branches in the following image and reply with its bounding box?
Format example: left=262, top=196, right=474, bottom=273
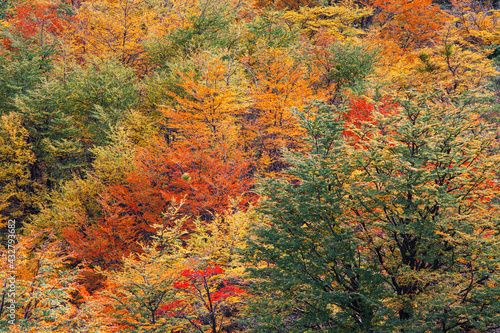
left=79, top=219, right=184, bottom=332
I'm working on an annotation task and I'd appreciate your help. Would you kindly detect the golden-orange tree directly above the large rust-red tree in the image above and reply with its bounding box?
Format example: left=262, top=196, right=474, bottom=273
left=163, top=53, right=246, bottom=147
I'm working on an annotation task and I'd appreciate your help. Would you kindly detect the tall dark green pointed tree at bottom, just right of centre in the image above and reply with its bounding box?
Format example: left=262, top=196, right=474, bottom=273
left=246, top=102, right=381, bottom=332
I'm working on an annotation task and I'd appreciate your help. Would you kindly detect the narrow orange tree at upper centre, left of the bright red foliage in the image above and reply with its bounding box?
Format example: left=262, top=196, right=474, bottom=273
left=242, top=49, right=321, bottom=172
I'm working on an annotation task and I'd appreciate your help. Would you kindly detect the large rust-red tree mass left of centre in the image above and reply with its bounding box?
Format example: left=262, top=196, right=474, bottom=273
left=64, top=139, right=255, bottom=267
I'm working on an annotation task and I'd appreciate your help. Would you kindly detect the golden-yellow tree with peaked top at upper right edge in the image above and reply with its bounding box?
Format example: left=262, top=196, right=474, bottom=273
left=375, top=23, right=497, bottom=102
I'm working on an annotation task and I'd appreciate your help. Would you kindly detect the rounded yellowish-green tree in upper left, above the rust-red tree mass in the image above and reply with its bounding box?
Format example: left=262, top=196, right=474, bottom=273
left=63, top=58, right=140, bottom=147
